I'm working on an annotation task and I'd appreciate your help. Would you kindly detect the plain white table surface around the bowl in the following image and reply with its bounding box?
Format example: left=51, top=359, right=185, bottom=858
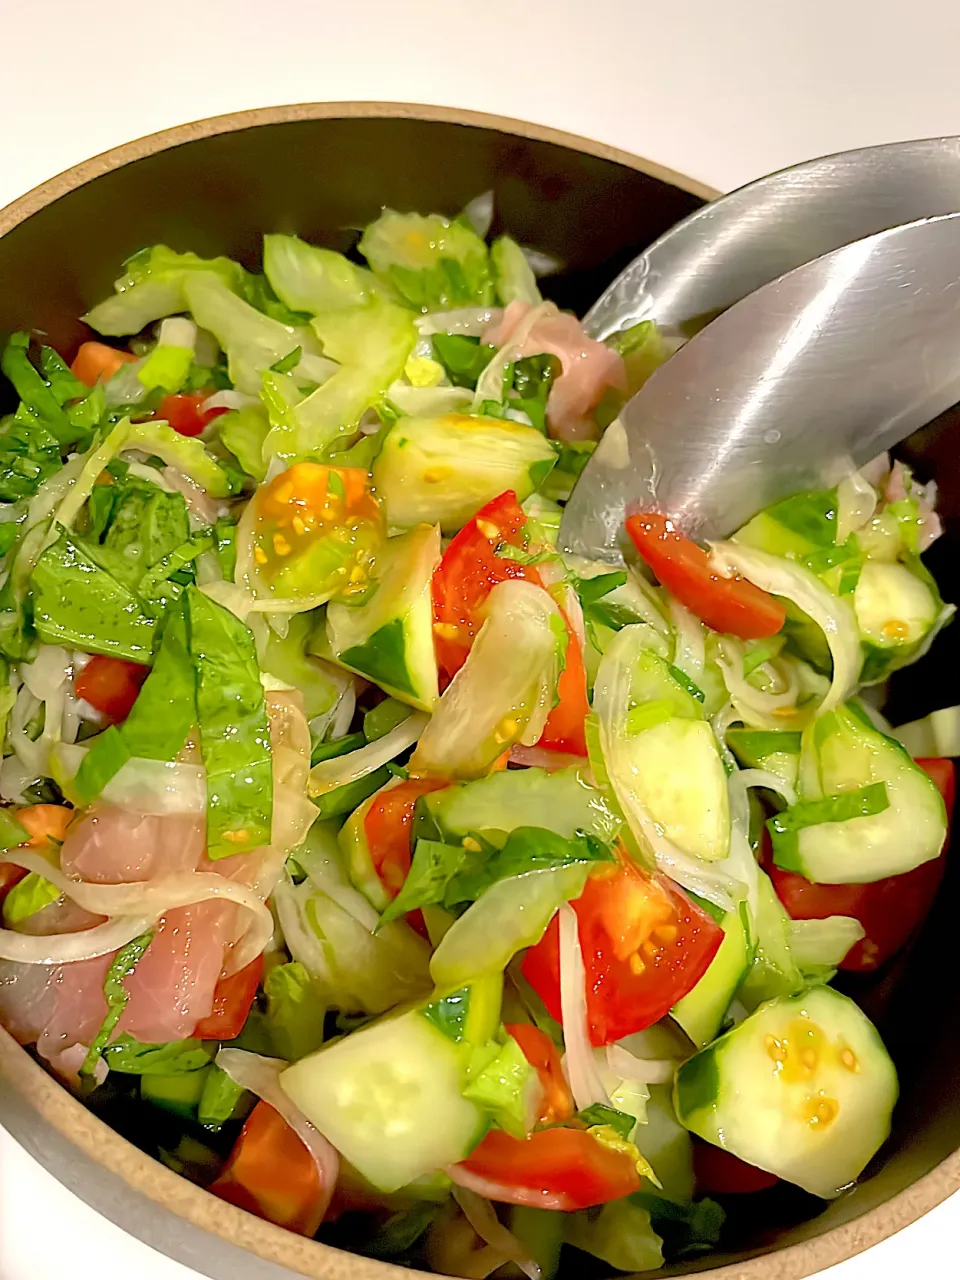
left=0, top=0, right=960, bottom=1280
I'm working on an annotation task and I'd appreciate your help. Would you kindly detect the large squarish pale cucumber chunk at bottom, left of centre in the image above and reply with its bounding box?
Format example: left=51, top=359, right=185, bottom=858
left=279, top=1009, right=486, bottom=1192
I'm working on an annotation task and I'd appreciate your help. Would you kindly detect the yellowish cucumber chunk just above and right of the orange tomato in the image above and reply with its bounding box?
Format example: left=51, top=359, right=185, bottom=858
left=374, top=413, right=557, bottom=534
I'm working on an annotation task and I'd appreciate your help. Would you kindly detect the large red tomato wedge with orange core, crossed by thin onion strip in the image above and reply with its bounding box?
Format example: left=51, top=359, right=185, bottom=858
left=522, top=858, right=723, bottom=1046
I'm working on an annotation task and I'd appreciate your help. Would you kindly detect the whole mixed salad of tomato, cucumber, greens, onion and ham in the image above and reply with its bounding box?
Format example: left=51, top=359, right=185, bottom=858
left=0, top=192, right=956, bottom=1280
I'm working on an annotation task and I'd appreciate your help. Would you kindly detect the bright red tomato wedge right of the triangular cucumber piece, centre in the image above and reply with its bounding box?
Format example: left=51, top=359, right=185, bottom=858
left=433, top=489, right=541, bottom=684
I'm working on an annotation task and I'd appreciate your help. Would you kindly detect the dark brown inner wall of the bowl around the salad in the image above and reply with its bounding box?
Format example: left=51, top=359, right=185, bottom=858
left=0, top=109, right=960, bottom=1275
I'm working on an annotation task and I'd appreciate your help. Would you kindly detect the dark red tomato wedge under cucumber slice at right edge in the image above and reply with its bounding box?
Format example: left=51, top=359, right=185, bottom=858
left=763, top=759, right=956, bottom=973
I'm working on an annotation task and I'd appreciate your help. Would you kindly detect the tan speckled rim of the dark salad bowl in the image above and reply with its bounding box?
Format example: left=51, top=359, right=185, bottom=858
left=0, top=101, right=960, bottom=1280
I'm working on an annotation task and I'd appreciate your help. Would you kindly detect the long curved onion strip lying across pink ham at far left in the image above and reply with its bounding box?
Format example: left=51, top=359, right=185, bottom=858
left=0, top=849, right=274, bottom=969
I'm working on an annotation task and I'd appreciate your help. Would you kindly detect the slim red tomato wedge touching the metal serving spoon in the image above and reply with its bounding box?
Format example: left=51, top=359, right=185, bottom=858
left=627, top=511, right=786, bottom=640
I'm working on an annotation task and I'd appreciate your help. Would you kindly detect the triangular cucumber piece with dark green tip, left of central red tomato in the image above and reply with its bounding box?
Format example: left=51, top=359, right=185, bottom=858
left=326, top=525, right=440, bottom=712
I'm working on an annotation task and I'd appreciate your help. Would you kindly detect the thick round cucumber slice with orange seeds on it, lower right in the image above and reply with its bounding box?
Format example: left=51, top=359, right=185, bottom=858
left=675, top=987, right=897, bottom=1199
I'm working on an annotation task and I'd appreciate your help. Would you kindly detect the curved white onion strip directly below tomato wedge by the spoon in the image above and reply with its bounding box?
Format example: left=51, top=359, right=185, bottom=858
left=710, top=543, right=860, bottom=716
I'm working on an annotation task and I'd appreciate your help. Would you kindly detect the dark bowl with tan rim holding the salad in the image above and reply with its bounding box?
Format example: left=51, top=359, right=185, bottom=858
left=0, top=102, right=960, bottom=1280
